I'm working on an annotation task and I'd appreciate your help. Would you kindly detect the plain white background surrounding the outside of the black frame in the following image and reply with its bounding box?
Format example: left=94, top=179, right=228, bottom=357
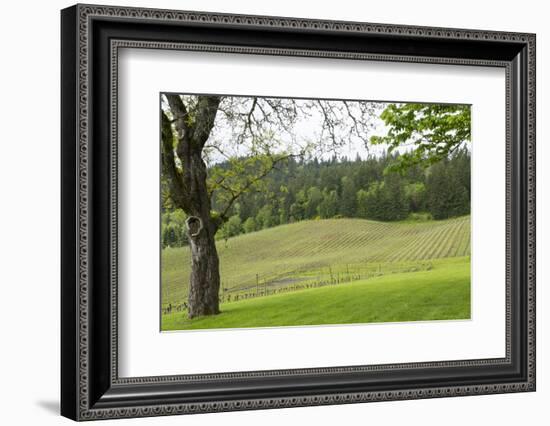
left=0, top=0, right=550, bottom=426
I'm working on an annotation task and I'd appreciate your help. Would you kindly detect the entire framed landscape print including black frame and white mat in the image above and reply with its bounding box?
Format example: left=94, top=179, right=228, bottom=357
left=61, top=5, right=535, bottom=420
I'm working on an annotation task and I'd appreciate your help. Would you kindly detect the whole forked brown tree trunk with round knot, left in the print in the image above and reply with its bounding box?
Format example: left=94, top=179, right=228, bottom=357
left=163, top=95, right=224, bottom=318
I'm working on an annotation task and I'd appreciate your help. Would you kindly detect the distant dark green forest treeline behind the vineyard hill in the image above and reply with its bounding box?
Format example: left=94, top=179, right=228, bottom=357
left=162, top=149, right=470, bottom=247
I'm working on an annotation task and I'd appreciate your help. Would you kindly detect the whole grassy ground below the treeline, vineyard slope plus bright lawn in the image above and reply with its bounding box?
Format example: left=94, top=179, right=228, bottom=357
left=162, top=216, right=470, bottom=330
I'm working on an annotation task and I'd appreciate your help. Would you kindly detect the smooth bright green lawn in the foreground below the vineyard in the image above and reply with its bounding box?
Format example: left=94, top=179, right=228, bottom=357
left=162, top=256, right=470, bottom=330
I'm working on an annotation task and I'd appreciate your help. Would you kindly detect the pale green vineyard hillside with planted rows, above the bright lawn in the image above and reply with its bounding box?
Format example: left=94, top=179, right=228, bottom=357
left=162, top=216, right=470, bottom=307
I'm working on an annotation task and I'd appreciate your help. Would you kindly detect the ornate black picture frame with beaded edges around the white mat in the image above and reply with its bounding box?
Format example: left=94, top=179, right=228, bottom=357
left=61, top=5, right=535, bottom=420
